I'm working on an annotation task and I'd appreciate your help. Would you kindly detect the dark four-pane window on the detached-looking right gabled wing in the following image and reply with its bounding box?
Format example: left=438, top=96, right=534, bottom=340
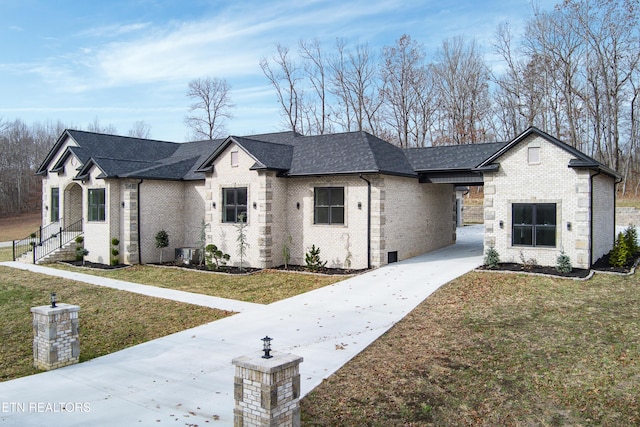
left=512, top=203, right=556, bottom=247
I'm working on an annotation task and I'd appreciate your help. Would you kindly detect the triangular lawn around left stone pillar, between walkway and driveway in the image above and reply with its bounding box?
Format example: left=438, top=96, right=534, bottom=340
left=0, top=267, right=232, bottom=381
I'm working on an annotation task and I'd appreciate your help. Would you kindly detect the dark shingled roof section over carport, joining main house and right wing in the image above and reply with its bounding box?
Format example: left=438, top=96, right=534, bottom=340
left=405, top=142, right=507, bottom=172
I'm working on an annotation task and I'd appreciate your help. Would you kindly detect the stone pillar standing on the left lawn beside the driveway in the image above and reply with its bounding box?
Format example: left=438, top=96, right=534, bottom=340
left=31, top=304, right=80, bottom=371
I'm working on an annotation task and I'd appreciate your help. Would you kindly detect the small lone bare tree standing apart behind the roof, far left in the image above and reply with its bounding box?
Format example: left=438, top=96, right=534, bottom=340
left=185, top=77, right=234, bottom=139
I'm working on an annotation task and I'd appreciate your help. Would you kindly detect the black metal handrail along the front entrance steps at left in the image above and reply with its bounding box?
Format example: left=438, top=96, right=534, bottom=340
left=13, top=219, right=82, bottom=264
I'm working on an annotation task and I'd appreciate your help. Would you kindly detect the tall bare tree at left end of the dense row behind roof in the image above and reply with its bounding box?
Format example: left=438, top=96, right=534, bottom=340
left=260, top=44, right=304, bottom=133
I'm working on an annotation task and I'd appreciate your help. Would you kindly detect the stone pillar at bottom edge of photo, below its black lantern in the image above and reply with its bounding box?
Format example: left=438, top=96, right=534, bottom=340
left=232, top=352, right=302, bottom=427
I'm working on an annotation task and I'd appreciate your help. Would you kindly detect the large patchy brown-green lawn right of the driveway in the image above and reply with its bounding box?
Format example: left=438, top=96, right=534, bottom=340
left=302, top=273, right=640, bottom=426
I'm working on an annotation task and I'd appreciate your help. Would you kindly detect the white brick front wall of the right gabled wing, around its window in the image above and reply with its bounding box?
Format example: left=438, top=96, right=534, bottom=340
left=484, top=135, right=613, bottom=268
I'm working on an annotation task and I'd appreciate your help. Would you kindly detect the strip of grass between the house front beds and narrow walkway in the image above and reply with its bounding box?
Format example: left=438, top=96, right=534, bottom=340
left=53, top=264, right=344, bottom=304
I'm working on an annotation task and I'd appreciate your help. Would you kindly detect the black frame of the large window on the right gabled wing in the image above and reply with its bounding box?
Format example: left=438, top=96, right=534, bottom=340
left=511, top=203, right=558, bottom=248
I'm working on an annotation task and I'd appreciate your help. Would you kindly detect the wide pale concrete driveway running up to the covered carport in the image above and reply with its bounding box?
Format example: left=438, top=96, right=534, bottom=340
left=0, top=226, right=482, bottom=426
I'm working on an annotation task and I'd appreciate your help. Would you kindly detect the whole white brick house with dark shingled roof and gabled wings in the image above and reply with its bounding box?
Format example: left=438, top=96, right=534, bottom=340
left=34, top=128, right=618, bottom=269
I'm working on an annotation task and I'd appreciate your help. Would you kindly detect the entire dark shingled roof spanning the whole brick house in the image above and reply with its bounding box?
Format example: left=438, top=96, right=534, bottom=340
left=38, top=128, right=617, bottom=180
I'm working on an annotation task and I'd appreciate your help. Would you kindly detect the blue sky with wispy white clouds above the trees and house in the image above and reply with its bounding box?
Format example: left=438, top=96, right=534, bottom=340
left=0, top=0, right=556, bottom=141
